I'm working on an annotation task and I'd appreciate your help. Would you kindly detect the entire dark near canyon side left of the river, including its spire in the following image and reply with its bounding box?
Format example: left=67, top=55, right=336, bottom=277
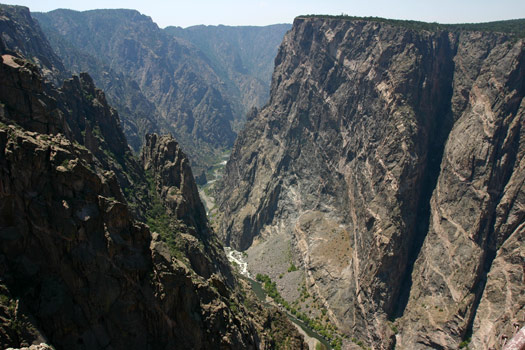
left=0, top=8, right=304, bottom=349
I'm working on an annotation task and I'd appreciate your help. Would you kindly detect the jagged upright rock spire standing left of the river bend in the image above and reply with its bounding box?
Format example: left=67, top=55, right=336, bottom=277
left=141, top=134, right=234, bottom=287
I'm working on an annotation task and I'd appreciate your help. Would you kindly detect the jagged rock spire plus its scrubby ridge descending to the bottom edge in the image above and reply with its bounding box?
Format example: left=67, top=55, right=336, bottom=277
left=141, top=134, right=308, bottom=350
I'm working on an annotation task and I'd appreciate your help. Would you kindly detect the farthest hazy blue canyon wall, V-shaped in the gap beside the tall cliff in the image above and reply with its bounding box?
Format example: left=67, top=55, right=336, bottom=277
left=164, top=24, right=291, bottom=130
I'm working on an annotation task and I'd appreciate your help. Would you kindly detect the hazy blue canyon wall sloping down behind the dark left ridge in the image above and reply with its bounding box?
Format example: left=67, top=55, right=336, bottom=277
left=35, top=10, right=235, bottom=173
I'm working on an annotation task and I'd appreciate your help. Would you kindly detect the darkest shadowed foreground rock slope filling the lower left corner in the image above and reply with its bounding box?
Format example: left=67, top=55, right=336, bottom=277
left=0, top=52, right=245, bottom=349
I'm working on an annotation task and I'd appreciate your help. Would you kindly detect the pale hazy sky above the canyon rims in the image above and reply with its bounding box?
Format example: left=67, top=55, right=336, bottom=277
left=0, top=0, right=525, bottom=27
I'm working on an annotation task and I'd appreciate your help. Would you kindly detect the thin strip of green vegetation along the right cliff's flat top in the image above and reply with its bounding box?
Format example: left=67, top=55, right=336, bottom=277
left=298, top=15, right=525, bottom=38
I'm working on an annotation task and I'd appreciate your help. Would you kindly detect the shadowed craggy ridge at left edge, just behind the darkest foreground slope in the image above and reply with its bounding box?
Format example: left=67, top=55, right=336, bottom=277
left=0, top=54, right=145, bottom=216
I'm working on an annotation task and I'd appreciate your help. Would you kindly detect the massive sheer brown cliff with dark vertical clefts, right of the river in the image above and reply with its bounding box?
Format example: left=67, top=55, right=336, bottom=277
left=219, top=17, right=525, bottom=349
